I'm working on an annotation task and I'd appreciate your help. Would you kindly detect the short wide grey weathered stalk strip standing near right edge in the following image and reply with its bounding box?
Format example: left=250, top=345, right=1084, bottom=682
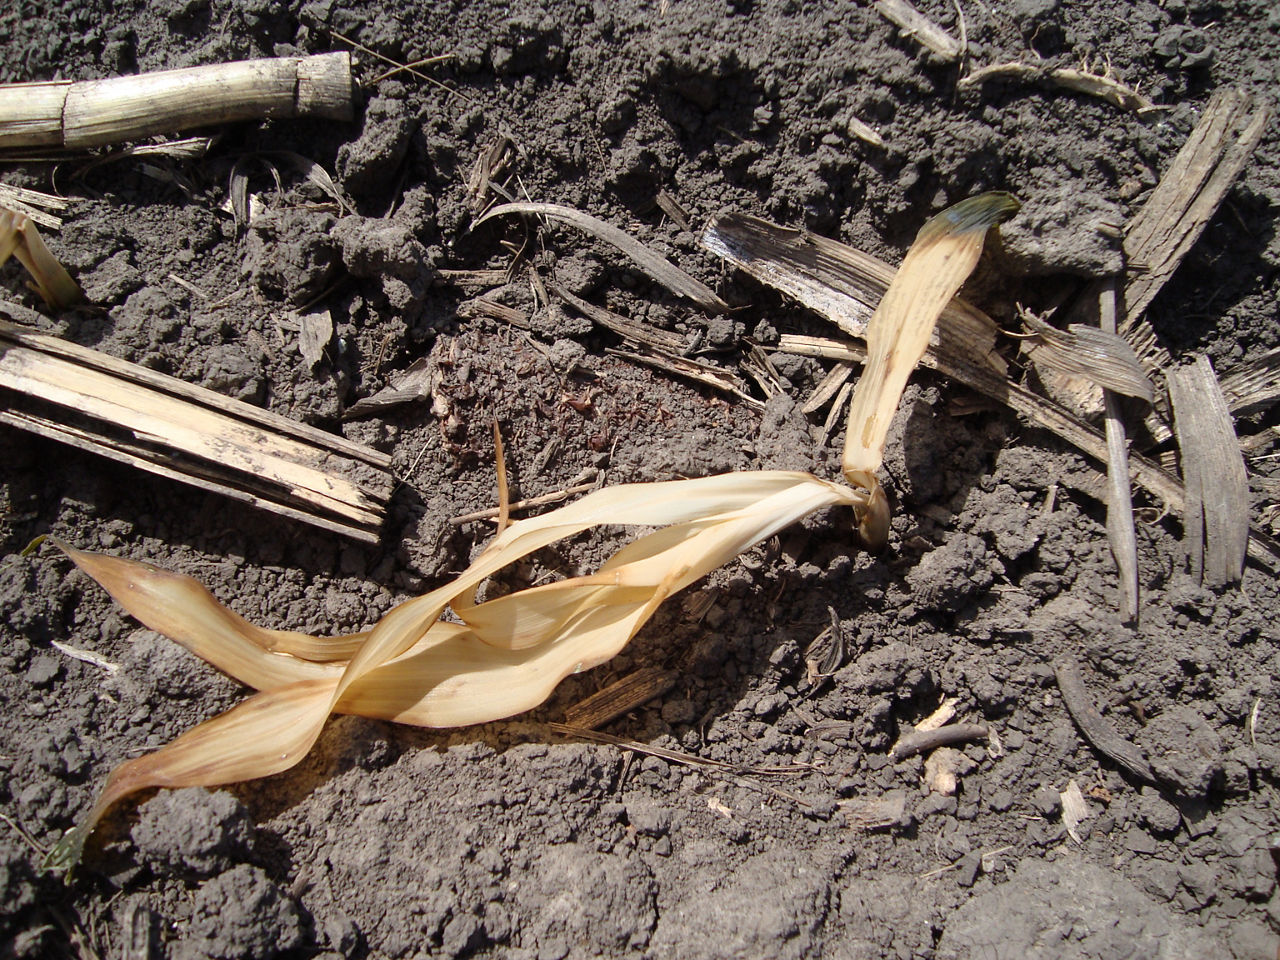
left=1167, top=356, right=1249, bottom=586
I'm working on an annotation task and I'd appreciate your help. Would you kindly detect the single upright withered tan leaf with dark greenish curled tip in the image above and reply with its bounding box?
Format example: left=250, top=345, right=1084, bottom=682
left=841, top=193, right=1018, bottom=549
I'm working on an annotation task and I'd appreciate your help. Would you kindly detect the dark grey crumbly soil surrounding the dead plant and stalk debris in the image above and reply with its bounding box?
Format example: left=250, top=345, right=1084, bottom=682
left=0, top=0, right=1280, bottom=960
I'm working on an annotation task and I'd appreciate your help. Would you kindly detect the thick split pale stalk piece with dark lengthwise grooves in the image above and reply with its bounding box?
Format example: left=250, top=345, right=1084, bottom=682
left=0, top=321, right=394, bottom=543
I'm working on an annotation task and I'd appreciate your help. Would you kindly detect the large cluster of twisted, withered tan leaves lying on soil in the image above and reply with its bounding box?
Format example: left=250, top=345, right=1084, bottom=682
left=49, top=471, right=867, bottom=869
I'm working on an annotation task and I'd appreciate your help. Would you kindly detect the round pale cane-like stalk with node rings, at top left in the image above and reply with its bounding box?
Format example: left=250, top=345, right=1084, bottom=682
left=0, top=52, right=356, bottom=150
